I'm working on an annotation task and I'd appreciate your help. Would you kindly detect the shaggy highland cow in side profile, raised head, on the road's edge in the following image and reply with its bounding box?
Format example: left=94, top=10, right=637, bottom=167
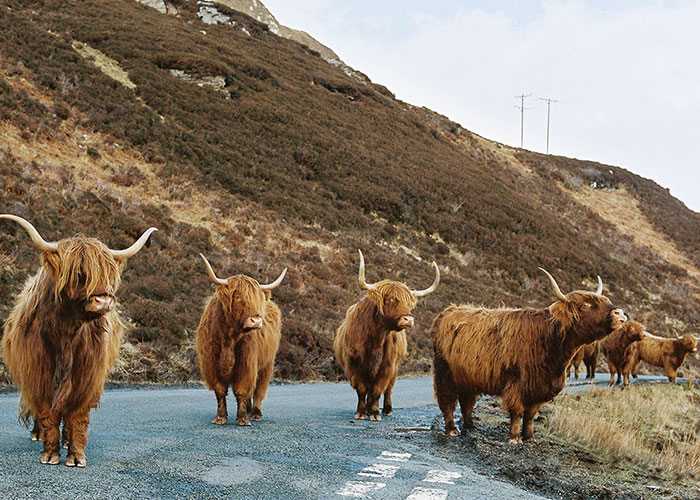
left=430, top=269, right=627, bottom=443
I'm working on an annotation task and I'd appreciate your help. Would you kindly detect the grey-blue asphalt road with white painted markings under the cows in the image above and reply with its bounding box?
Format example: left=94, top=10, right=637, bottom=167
left=0, top=374, right=660, bottom=500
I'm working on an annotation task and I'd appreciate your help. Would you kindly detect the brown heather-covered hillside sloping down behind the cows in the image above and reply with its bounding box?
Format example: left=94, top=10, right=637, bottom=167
left=0, top=0, right=700, bottom=382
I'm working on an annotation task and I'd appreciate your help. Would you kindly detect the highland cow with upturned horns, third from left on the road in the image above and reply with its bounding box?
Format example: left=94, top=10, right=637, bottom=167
left=333, top=250, right=440, bottom=420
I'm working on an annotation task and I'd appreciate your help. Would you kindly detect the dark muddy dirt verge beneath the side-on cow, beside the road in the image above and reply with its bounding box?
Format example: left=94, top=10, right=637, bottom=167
left=432, top=396, right=700, bottom=499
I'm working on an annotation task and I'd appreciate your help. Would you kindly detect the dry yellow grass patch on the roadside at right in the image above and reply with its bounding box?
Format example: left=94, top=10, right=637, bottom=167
left=546, top=384, right=700, bottom=476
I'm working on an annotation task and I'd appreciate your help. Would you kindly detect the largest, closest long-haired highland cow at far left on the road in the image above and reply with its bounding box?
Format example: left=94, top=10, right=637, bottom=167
left=0, top=215, right=156, bottom=467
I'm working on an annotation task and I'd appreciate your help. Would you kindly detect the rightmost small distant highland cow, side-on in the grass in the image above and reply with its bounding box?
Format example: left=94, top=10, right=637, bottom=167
left=622, top=332, right=698, bottom=386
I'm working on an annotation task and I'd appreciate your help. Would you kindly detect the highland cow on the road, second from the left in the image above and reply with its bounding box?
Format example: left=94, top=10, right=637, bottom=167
left=197, top=254, right=287, bottom=425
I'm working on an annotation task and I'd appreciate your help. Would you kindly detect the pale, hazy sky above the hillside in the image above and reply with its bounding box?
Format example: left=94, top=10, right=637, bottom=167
left=263, top=0, right=700, bottom=212
